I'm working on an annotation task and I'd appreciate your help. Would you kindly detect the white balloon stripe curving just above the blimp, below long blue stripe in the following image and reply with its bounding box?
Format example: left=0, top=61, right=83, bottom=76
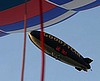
left=7, top=10, right=76, bottom=33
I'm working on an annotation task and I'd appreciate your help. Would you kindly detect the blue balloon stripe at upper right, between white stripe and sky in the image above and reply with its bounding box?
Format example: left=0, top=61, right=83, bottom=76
left=73, top=0, right=100, bottom=11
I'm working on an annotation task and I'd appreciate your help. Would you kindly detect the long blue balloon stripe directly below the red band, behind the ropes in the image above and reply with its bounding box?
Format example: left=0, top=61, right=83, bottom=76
left=0, top=7, right=68, bottom=32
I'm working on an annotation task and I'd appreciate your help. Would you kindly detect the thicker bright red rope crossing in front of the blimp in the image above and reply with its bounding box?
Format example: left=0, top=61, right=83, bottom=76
left=39, top=0, right=45, bottom=81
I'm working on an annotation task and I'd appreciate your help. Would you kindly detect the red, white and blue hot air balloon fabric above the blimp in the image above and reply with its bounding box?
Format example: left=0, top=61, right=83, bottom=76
left=0, top=0, right=100, bottom=37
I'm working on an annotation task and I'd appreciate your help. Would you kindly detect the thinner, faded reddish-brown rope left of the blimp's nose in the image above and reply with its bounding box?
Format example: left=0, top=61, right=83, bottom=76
left=21, top=0, right=27, bottom=81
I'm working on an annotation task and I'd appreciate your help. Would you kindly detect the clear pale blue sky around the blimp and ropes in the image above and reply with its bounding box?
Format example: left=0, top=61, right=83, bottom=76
left=0, top=7, right=100, bottom=81
